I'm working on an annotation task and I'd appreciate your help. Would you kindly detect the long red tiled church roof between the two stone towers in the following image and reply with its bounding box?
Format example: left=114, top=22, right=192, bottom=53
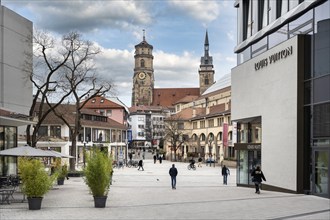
left=152, top=88, right=199, bottom=107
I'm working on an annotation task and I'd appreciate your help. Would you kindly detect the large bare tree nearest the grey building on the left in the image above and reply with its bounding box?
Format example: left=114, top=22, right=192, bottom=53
left=25, top=31, right=72, bottom=147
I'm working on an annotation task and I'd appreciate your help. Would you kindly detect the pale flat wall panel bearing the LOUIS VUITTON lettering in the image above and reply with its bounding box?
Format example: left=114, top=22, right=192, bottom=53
left=231, top=37, right=298, bottom=190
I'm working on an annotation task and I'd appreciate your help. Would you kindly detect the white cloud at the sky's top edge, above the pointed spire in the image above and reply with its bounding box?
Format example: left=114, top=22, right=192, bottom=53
left=169, top=0, right=220, bottom=25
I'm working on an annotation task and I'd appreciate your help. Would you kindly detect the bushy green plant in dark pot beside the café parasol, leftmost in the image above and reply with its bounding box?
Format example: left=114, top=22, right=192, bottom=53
left=18, top=158, right=57, bottom=210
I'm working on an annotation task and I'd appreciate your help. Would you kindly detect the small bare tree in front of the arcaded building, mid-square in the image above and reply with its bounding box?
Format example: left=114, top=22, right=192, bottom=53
left=165, top=115, right=187, bottom=161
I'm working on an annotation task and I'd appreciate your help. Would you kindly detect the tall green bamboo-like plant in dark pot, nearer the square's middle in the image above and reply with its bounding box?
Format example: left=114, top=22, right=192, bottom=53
left=84, top=150, right=112, bottom=208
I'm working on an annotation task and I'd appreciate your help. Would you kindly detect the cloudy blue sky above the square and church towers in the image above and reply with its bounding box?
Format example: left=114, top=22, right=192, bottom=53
left=0, top=0, right=236, bottom=107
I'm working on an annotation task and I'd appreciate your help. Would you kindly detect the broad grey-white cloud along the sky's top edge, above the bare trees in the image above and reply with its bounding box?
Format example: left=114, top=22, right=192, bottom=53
left=14, top=0, right=152, bottom=33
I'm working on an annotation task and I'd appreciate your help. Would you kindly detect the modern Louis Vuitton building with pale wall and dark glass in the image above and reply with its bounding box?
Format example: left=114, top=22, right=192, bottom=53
left=231, top=0, right=330, bottom=198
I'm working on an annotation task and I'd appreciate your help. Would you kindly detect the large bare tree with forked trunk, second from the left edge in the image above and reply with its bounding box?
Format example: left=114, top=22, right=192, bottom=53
left=55, top=32, right=112, bottom=170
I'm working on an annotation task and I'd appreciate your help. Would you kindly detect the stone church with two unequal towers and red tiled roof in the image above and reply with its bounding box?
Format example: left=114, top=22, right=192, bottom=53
left=132, top=31, right=214, bottom=108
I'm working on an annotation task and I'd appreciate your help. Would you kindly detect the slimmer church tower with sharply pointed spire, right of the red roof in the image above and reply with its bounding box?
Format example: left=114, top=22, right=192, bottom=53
left=198, top=31, right=214, bottom=94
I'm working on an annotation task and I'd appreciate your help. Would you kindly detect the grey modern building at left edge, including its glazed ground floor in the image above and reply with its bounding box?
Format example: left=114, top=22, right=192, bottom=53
left=0, top=3, right=33, bottom=176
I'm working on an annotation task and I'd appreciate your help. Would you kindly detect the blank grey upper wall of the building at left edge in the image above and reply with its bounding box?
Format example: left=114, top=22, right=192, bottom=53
left=0, top=6, right=33, bottom=114
